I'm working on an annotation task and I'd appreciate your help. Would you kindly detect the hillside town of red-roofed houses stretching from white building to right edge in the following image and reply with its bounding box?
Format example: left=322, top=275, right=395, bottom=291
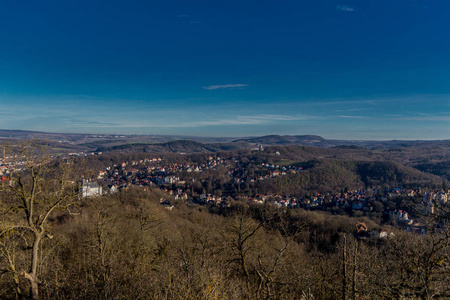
left=75, top=156, right=450, bottom=232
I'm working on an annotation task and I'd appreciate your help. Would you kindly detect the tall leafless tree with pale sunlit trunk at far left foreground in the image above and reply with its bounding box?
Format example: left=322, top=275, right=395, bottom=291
left=0, top=142, right=77, bottom=299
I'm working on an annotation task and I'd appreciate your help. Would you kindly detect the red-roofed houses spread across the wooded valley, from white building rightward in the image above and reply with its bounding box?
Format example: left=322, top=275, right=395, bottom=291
left=74, top=156, right=450, bottom=231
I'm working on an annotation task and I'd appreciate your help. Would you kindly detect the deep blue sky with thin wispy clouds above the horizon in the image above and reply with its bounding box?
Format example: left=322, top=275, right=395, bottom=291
left=0, top=0, right=450, bottom=139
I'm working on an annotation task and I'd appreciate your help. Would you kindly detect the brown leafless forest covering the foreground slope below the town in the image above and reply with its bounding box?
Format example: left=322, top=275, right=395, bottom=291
left=1, top=190, right=450, bottom=299
